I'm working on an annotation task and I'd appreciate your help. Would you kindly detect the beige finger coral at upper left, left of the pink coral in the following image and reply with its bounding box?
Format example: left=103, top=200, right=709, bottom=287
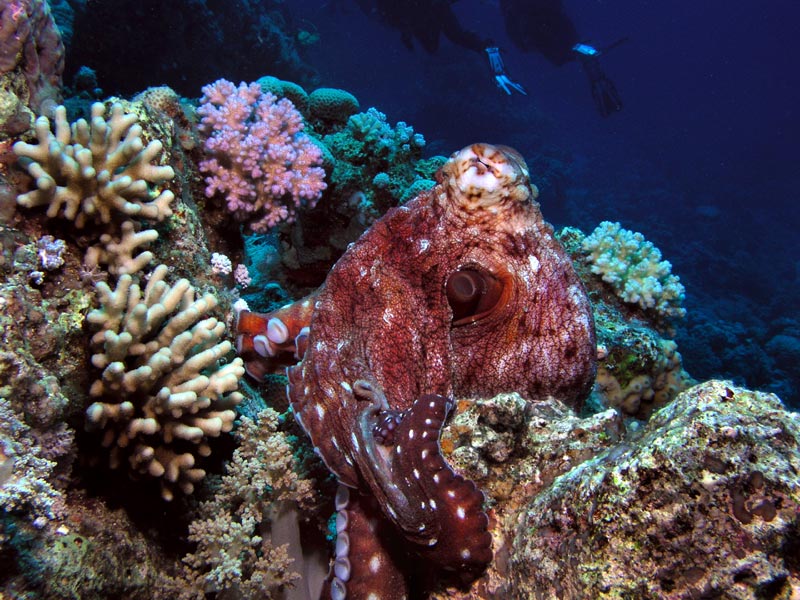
left=14, top=102, right=175, bottom=228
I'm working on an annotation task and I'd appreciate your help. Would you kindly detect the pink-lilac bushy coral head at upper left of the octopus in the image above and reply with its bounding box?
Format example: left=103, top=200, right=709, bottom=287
left=198, top=79, right=326, bottom=232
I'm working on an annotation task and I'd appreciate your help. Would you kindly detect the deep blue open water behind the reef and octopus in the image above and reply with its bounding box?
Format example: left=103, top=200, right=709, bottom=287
left=68, top=0, right=800, bottom=407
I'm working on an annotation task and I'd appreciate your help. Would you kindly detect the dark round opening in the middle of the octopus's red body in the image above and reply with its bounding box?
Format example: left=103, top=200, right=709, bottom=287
left=445, top=267, right=508, bottom=326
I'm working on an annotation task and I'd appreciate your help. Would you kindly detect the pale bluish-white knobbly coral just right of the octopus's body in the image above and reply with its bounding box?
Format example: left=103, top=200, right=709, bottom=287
left=583, top=221, right=686, bottom=317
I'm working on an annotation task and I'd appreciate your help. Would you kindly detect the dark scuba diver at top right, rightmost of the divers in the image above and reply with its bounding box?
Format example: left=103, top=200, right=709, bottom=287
left=494, top=0, right=625, bottom=117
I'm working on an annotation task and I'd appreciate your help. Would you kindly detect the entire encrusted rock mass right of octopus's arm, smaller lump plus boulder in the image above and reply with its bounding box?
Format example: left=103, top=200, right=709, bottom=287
left=432, top=381, right=800, bottom=600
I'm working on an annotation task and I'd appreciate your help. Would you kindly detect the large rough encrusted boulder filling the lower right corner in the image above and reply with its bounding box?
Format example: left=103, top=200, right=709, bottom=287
left=509, top=381, right=800, bottom=599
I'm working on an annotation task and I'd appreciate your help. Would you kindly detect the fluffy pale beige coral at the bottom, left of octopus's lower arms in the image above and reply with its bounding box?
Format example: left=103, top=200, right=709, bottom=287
left=184, top=409, right=311, bottom=598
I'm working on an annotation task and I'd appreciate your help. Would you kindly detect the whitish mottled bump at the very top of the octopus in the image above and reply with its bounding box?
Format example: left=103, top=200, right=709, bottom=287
left=441, top=144, right=539, bottom=212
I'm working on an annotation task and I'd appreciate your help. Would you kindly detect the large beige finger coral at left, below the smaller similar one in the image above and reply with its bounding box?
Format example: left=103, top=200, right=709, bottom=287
left=86, top=265, right=244, bottom=500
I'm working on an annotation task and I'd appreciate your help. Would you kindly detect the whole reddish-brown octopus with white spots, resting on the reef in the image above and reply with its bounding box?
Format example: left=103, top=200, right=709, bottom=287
left=237, top=144, right=596, bottom=600
